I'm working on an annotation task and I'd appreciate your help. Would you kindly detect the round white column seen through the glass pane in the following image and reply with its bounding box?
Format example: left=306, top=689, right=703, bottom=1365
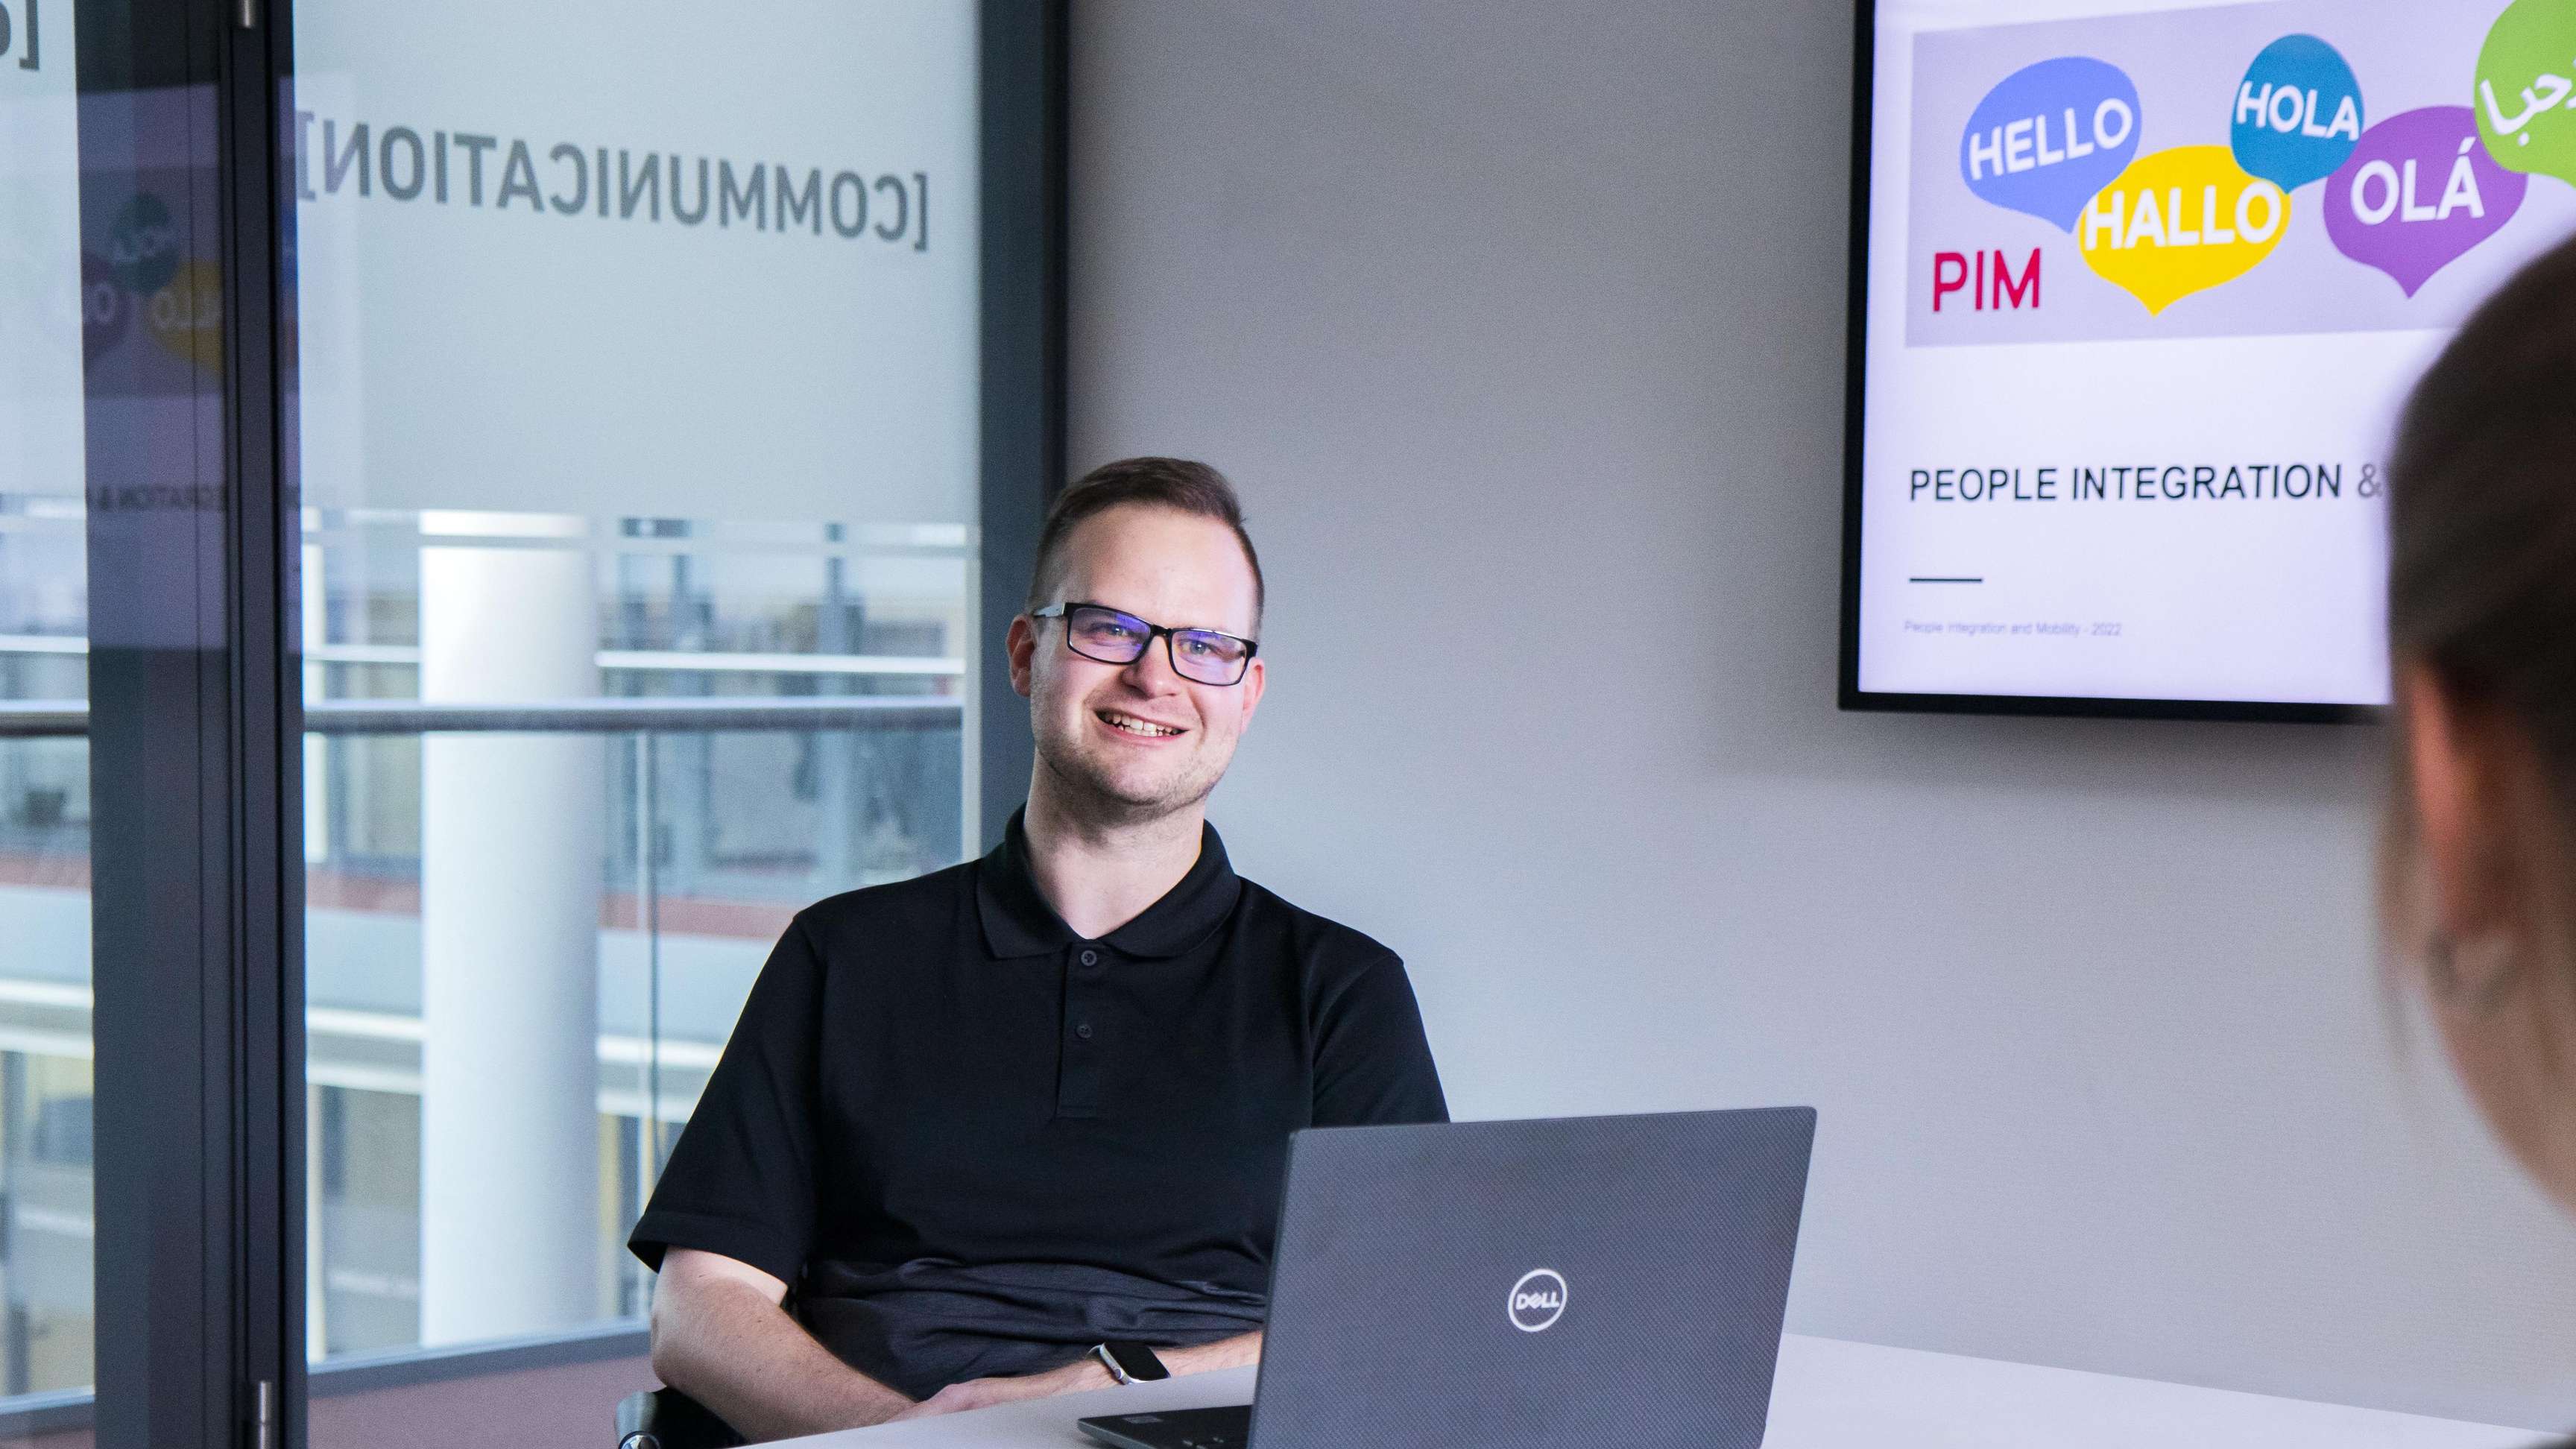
left=420, top=513, right=608, bottom=1343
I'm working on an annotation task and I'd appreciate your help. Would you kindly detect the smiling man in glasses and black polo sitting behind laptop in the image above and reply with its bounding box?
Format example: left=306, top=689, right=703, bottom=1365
left=615, top=459, right=1448, bottom=1439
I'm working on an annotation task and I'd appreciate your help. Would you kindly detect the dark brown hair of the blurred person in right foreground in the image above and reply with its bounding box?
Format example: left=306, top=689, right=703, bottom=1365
left=2380, top=228, right=2576, bottom=1036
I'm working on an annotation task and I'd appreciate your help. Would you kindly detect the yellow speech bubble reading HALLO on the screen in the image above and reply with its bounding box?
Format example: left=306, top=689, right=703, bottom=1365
left=2077, top=147, right=2290, bottom=315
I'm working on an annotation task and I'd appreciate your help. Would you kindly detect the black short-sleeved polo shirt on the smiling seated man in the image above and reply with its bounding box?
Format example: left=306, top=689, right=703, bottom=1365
left=628, top=818, right=1448, bottom=1398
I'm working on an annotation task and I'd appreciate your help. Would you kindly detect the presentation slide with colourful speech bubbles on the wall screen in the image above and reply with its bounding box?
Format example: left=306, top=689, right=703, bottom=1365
left=1847, top=0, right=2576, bottom=707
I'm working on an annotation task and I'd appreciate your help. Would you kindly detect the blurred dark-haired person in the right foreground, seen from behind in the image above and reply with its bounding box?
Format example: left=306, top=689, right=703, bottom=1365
left=2380, top=240, right=2576, bottom=1433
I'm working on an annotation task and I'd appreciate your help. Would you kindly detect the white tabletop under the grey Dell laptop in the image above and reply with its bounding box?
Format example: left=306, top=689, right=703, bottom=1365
left=772, top=1333, right=2537, bottom=1449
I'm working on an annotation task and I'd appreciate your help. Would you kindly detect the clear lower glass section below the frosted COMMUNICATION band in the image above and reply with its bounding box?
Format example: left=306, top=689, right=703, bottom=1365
left=304, top=513, right=971, bottom=1359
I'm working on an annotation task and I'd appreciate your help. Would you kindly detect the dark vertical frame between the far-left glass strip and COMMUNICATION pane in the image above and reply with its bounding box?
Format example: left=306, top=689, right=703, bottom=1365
left=84, top=0, right=304, bottom=1447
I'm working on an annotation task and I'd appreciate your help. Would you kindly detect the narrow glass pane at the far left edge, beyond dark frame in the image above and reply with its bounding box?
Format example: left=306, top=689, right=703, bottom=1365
left=0, top=0, right=92, bottom=1413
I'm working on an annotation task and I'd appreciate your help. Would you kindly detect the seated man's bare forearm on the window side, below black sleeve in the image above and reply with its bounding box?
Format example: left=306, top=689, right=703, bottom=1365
left=651, top=1281, right=912, bottom=1442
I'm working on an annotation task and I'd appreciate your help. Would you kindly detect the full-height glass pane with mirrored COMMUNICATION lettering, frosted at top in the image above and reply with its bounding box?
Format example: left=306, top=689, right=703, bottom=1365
left=283, top=0, right=984, bottom=1447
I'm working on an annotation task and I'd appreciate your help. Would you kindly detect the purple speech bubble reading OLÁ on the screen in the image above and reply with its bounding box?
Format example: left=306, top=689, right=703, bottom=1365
left=2323, top=106, right=2530, bottom=297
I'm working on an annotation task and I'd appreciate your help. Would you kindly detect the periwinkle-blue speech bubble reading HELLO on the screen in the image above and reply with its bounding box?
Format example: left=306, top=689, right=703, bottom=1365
left=1958, top=54, right=2138, bottom=232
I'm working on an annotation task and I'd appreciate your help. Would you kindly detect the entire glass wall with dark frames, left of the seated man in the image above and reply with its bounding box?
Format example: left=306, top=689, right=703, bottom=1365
left=0, top=0, right=1061, bottom=1444
